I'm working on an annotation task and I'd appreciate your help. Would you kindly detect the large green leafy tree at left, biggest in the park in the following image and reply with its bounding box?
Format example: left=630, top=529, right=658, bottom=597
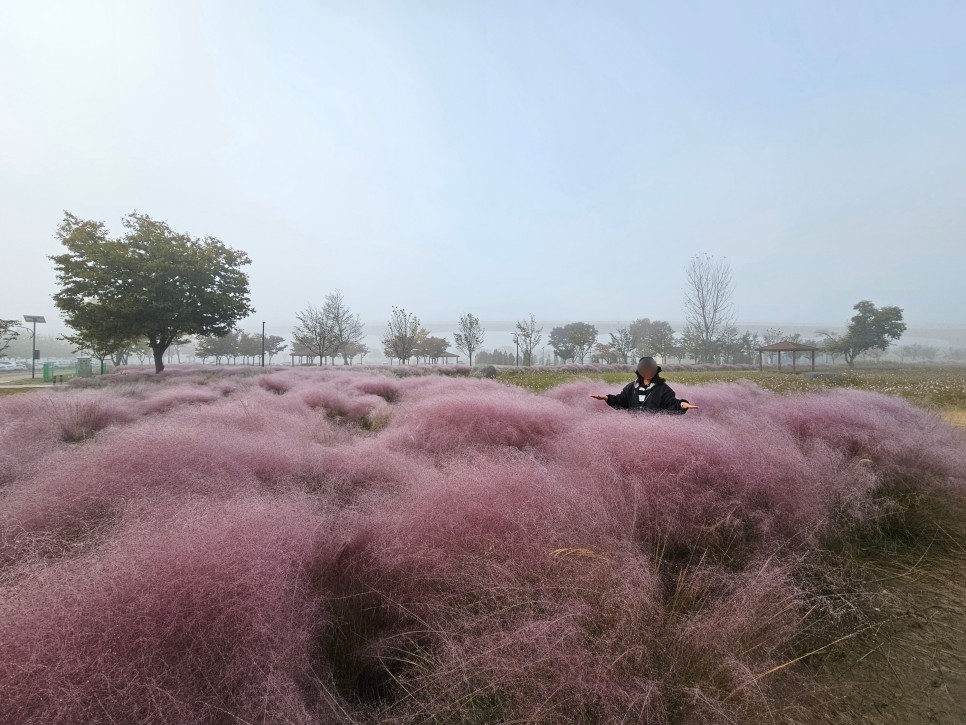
left=51, top=212, right=254, bottom=372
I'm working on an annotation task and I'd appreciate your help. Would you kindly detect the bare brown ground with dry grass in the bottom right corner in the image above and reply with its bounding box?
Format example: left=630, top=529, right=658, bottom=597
left=806, top=492, right=966, bottom=725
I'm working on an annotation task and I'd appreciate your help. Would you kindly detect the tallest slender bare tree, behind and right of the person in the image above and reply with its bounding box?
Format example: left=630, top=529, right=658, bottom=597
left=684, top=254, right=735, bottom=362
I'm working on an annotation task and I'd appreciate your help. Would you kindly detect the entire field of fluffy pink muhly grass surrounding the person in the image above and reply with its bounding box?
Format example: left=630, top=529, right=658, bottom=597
left=0, top=368, right=966, bottom=723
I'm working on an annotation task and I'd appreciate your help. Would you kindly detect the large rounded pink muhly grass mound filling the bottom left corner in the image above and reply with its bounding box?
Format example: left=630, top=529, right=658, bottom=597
left=0, top=497, right=348, bottom=723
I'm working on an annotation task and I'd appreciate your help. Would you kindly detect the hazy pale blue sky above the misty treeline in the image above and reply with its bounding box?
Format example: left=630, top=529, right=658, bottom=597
left=0, top=0, right=966, bottom=334
